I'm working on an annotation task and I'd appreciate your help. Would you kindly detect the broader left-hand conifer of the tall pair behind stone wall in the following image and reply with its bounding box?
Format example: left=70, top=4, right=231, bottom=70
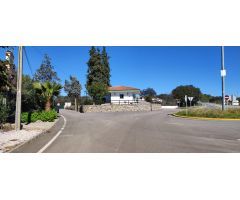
left=86, top=47, right=108, bottom=104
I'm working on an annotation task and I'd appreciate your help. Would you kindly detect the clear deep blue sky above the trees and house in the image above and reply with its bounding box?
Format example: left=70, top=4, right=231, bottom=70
left=0, top=46, right=240, bottom=96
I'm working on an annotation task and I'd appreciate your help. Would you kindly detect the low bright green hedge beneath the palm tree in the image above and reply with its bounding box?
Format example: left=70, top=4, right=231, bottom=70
left=21, top=110, right=57, bottom=123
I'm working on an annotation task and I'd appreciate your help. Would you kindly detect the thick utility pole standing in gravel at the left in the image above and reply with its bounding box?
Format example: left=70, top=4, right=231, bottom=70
left=15, top=46, right=23, bottom=131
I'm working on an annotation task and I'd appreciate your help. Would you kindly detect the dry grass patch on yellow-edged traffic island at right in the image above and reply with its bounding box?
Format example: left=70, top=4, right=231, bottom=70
left=176, top=108, right=240, bottom=119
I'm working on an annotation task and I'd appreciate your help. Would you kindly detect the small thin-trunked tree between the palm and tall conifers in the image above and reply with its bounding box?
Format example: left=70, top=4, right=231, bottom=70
left=64, top=76, right=82, bottom=111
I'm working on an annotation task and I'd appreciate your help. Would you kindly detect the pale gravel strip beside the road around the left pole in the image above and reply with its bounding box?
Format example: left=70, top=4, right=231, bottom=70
left=0, top=119, right=58, bottom=153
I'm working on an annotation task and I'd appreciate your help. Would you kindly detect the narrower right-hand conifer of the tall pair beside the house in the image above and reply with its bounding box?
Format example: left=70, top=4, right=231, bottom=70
left=101, top=47, right=111, bottom=87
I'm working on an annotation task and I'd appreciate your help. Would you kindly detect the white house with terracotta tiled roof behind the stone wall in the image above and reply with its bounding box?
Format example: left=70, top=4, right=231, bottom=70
left=107, top=86, right=140, bottom=104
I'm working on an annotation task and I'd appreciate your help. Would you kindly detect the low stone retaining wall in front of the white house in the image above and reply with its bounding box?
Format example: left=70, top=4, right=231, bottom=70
left=82, top=103, right=161, bottom=113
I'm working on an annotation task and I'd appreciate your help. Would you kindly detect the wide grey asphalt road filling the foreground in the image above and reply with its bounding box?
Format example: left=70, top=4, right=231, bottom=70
left=14, top=110, right=240, bottom=153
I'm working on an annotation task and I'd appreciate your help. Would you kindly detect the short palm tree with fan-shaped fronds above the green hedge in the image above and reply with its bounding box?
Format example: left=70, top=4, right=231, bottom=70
left=33, top=81, right=62, bottom=111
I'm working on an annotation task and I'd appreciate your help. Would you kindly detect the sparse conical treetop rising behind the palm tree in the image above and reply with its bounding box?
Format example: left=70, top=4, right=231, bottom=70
left=34, top=54, right=60, bottom=83
